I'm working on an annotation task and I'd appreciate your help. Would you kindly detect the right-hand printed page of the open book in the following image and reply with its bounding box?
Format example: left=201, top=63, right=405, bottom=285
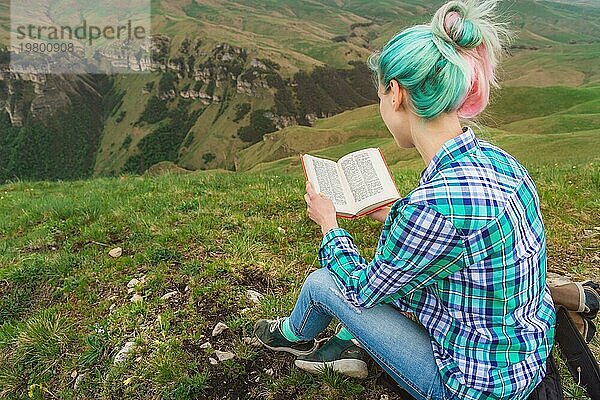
left=338, top=148, right=400, bottom=210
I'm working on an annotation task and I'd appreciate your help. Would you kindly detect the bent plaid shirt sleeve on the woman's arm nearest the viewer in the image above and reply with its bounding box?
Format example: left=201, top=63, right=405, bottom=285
left=319, top=204, right=464, bottom=308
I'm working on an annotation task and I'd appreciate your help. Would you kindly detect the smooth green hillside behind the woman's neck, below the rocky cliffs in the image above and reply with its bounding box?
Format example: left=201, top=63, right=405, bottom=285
left=236, top=86, right=600, bottom=171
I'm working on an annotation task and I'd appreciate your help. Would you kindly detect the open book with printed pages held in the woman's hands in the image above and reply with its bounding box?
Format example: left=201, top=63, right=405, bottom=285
left=300, top=148, right=400, bottom=219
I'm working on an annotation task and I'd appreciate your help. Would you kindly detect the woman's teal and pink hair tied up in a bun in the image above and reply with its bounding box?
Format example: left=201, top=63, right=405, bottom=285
left=367, top=0, right=509, bottom=119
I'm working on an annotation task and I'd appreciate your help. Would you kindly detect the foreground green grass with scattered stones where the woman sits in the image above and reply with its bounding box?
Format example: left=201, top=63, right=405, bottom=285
left=0, top=155, right=600, bottom=399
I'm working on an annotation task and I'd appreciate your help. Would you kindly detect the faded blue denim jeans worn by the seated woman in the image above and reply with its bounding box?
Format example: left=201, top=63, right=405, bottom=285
left=289, top=268, right=455, bottom=400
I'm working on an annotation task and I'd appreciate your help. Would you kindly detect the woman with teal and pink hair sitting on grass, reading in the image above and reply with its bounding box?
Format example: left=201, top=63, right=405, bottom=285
left=255, top=0, right=555, bottom=399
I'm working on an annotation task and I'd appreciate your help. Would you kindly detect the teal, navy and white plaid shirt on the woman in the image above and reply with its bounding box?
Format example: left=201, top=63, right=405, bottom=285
left=319, top=127, right=556, bottom=399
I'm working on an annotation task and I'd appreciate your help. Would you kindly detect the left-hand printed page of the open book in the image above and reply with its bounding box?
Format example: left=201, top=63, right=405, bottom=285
left=302, top=154, right=351, bottom=213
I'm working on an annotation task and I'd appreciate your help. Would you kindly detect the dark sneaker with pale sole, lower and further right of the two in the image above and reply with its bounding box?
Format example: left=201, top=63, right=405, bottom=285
left=295, top=336, right=370, bottom=379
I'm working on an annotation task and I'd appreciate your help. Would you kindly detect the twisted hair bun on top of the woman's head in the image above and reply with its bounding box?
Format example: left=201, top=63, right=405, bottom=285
left=431, top=1, right=483, bottom=49
